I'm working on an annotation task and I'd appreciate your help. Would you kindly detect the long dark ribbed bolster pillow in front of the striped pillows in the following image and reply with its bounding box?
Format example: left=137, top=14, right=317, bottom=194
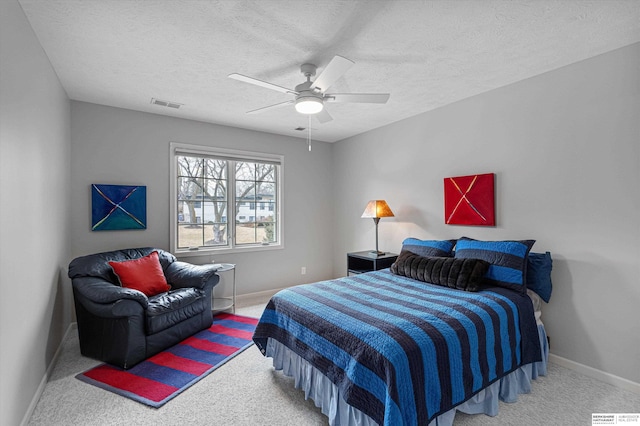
left=391, top=250, right=490, bottom=291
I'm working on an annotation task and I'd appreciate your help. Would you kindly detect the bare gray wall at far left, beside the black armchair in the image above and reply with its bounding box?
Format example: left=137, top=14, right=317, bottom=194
left=0, top=0, right=71, bottom=425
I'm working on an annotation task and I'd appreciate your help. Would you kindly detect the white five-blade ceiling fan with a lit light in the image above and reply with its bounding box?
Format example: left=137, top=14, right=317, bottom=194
left=229, top=55, right=390, bottom=123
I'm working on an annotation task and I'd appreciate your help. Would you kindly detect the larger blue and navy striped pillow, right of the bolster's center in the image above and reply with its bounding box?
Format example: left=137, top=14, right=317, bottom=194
left=455, top=237, right=535, bottom=293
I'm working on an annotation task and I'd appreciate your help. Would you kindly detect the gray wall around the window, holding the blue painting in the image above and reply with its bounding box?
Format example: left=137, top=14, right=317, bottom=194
left=70, top=101, right=333, bottom=294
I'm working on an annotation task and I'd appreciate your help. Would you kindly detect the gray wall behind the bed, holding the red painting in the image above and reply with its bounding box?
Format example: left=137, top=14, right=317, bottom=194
left=333, top=44, right=640, bottom=383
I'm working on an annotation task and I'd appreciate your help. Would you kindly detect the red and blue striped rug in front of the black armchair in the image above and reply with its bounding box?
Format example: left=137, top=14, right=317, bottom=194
left=76, top=313, right=258, bottom=408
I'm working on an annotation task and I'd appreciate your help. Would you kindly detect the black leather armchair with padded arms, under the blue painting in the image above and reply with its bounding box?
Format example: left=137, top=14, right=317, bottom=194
left=69, top=247, right=220, bottom=369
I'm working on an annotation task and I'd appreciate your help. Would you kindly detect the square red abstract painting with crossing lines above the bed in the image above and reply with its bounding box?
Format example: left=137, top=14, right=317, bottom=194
left=444, top=173, right=496, bottom=226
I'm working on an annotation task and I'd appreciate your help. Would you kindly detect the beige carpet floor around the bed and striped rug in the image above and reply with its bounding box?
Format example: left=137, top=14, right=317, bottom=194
left=28, top=302, right=640, bottom=426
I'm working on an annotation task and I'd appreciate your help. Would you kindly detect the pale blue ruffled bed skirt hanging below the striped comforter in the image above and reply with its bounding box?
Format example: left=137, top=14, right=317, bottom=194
left=265, top=324, right=549, bottom=426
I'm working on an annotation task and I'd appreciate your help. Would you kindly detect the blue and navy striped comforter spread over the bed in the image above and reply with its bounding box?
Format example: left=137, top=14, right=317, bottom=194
left=253, top=270, right=541, bottom=426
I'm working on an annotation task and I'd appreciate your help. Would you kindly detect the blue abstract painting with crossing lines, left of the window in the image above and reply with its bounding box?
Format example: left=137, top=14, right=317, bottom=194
left=91, top=184, right=147, bottom=231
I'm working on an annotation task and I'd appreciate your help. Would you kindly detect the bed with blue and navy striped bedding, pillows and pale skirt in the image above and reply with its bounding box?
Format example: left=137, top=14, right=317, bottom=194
left=254, top=239, right=548, bottom=426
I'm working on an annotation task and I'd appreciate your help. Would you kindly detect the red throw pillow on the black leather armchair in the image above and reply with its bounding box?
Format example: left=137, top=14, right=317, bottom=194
left=109, top=251, right=171, bottom=296
